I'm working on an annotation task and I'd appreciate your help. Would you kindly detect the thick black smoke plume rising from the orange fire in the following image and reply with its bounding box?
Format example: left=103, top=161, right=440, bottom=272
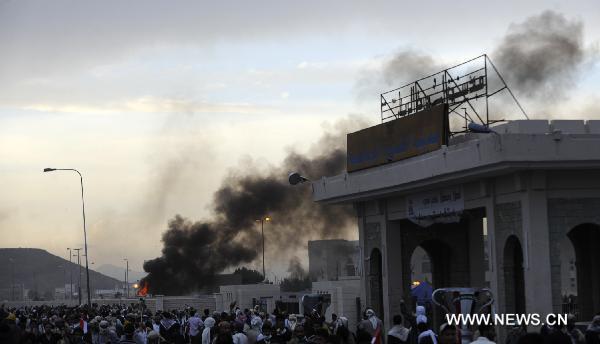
left=144, top=120, right=366, bottom=295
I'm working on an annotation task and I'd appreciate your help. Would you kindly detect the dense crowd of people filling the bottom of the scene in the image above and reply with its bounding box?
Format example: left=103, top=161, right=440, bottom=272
left=0, top=303, right=600, bottom=344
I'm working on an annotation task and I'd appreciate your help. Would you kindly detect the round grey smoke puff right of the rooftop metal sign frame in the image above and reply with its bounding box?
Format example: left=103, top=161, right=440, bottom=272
left=492, top=11, right=587, bottom=101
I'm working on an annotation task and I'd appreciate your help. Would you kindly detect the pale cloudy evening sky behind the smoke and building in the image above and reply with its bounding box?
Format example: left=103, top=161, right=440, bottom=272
left=0, top=0, right=600, bottom=277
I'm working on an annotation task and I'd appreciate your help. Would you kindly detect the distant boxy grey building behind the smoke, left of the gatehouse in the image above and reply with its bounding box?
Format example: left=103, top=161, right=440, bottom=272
left=308, top=240, right=360, bottom=281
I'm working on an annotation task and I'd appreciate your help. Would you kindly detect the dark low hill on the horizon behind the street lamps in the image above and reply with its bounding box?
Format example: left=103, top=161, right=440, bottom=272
left=0, top=248, right=122, bottom=295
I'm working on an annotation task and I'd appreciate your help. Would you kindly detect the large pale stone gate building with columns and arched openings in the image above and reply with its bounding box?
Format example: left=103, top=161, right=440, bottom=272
left=313, top=119, right=600, bottom=334
